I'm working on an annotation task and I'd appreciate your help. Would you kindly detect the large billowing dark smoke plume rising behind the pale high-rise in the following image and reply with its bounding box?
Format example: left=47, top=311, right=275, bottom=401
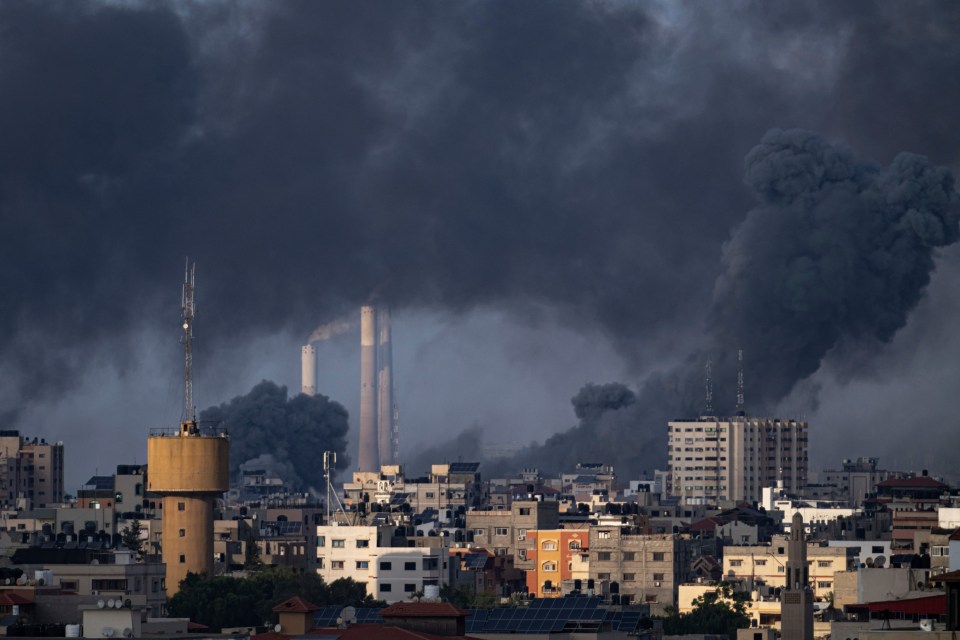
left=498, top=130, right=960, bottom=474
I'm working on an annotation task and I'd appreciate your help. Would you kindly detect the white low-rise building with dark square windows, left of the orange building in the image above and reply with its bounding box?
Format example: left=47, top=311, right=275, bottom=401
left=316, top=525, right=450, bottom=603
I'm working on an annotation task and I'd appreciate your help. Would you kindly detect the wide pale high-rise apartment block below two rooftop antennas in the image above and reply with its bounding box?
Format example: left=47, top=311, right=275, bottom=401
left=667, top=416, right=808, bottom=504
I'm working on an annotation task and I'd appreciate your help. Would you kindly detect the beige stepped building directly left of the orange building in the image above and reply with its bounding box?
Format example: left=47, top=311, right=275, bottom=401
left=466, top=499, right=560, bottom=571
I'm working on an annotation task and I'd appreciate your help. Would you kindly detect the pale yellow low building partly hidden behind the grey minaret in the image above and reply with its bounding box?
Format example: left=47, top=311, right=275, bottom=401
left=723, top=536, right=861, bottom=599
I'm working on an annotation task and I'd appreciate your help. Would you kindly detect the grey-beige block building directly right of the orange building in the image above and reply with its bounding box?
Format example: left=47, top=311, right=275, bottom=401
left=589, top=525, right=716, bottom=614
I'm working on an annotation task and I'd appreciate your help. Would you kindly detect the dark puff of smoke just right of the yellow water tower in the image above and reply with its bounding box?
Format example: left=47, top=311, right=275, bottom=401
left=200, top=381, right=350, bottom=491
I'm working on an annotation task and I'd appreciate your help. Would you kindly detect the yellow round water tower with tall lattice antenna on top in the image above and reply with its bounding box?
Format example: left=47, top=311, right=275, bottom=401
left=147, top=263, right=230, bottom=594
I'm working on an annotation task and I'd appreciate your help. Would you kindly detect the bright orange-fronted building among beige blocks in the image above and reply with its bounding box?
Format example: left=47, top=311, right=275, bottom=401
left=526, top=529, right=590, bottom=598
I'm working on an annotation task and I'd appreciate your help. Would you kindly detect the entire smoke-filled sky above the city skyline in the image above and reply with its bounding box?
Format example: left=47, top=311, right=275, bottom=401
left=0, top=0, right=960, bottom=487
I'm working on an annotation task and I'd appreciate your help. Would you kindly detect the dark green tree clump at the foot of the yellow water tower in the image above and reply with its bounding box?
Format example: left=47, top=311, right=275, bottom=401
left=167, top=567, right=384, bottom=629
